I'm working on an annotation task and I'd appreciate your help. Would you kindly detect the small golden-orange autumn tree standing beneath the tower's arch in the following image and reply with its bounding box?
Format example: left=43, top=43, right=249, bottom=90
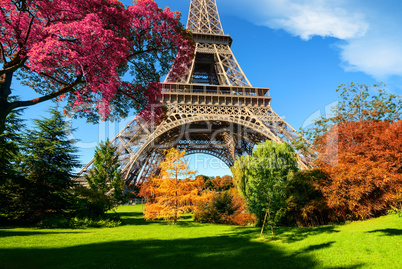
left=140, top=148, right=205, bottom=223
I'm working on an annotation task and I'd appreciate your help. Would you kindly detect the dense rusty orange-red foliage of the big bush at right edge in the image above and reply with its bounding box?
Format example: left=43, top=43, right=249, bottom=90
left=317, top=121, right=402, bottom=219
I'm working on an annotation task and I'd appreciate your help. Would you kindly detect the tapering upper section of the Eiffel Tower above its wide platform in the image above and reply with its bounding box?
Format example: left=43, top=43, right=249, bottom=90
left=165, top=0, right=251, bottom=87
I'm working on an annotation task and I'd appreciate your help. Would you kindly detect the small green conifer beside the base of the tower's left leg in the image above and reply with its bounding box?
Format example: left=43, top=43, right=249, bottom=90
left=85, top=139, right=123, bottom=209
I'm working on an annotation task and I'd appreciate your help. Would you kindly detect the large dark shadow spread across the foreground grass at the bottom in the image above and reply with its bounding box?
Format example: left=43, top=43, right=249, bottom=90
left=0, top=235, right=359, bottom=269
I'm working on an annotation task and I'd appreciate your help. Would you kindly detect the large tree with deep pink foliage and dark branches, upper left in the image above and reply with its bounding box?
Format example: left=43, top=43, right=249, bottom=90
left=0, top=0, right=194, bottom=133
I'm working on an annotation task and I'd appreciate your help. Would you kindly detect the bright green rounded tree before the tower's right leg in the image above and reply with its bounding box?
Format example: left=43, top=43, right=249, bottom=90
left=232, top=141, right=298, bottom=237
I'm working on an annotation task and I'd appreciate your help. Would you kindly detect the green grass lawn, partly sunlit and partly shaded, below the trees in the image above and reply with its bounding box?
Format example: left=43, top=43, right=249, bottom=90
left=0, top=206, right=402, bottom=269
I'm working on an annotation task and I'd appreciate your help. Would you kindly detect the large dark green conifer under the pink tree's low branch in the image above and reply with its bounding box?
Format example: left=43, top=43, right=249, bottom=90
left=21, top=108, right=79, bottom=221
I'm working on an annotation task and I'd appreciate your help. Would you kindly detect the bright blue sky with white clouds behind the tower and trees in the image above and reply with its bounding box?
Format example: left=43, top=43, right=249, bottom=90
left=13, top=0, right=402, bottom=176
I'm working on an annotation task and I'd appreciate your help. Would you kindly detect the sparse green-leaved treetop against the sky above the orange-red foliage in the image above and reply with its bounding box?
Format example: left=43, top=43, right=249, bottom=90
left=302, top=83, right=402, bottom=141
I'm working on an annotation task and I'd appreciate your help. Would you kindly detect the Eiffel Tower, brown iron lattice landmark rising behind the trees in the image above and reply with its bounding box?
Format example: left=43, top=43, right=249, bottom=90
left=79, top=0, right=308, bottom=187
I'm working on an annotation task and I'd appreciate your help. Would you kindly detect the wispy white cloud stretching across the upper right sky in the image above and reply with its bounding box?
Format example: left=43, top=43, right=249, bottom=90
left=223, top=0, right=402, bottom=80
